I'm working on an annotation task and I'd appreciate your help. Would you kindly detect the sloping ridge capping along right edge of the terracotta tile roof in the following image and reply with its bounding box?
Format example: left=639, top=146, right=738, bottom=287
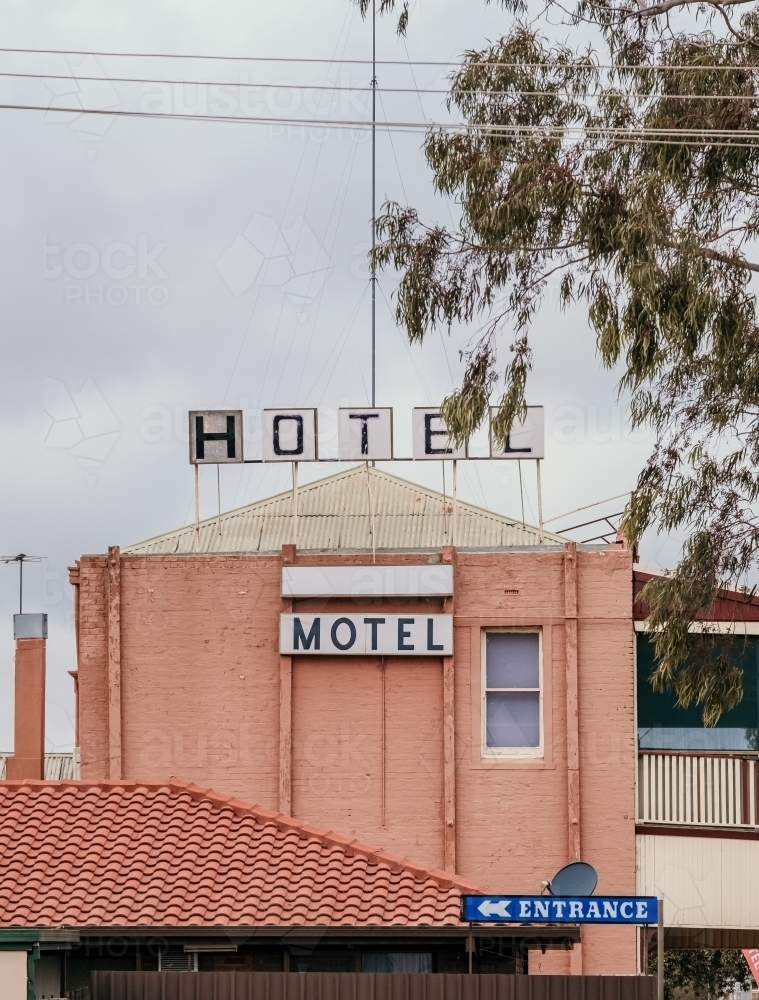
left=168, top=777, right=487, bottom=893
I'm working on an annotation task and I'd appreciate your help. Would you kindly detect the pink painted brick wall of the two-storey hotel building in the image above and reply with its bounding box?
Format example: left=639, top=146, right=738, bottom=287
left=79, top=547, right=635, bottom=974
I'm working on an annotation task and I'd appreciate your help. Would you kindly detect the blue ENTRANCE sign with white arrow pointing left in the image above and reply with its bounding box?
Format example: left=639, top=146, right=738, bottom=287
left=461, top=896, right=659, bottom=924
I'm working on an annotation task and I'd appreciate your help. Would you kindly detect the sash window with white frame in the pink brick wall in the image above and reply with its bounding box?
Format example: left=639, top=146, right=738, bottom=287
left=483, top=632, right=543, bottom=757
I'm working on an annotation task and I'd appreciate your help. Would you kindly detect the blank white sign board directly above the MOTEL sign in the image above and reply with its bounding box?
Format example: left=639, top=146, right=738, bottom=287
left=282, top=563, right=453, bottom=597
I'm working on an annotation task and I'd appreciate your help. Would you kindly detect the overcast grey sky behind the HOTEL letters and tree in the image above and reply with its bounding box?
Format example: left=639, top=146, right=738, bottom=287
left=0, top=0, right=671, bottom=750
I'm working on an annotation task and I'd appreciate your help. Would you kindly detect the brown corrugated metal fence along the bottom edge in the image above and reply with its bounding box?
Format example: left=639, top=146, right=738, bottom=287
left=92, top=972, right=656, bottom=1000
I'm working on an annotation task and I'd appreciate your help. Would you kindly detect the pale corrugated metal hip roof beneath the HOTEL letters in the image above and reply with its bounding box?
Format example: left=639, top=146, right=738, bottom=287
left=122, top=466, right=565, bottom=555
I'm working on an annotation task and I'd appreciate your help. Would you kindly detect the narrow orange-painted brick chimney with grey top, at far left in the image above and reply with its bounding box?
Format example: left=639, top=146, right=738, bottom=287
left=5, top=614, right=47, bottom=781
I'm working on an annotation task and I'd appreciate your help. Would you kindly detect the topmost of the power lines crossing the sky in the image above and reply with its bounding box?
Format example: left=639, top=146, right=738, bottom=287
left=0, top=47, right=759, bottom=73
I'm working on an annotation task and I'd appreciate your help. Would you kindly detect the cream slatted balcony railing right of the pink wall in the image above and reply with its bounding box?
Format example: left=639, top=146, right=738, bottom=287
left=638, top=750, right=759, bottom=827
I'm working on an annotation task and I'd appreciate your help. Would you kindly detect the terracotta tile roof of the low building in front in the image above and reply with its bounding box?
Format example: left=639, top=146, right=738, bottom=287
left=0, top=778, right=483, bottom=927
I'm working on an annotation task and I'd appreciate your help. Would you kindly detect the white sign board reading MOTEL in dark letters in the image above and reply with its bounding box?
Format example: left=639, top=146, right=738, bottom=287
left=279, top=614, right=453, bottom=656
